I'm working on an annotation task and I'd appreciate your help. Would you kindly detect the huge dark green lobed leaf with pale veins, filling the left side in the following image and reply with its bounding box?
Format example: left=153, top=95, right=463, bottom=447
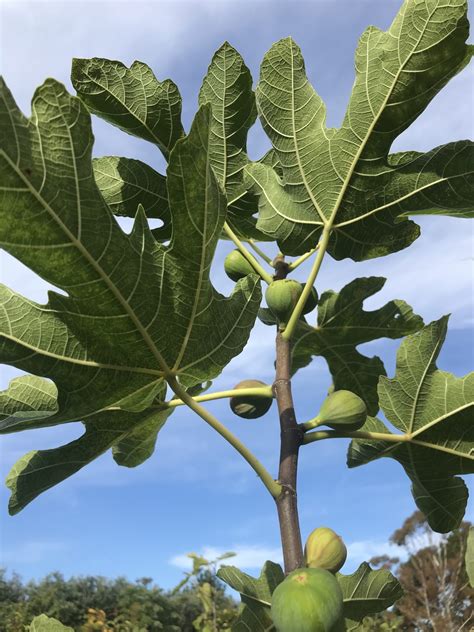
left=0, top=79, right=261, bottom=508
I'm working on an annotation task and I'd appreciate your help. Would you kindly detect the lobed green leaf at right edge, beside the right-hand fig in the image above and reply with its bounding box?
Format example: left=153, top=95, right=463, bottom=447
left=348, top=316, right=474, bottom=533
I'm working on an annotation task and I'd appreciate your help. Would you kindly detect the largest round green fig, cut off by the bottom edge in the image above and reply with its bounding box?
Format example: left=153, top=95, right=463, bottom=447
left=271, top=568, right=344, bottom=632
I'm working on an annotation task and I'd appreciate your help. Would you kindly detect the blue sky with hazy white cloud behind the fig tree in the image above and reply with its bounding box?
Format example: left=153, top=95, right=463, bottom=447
left=0, top=0, right=474, bottom=587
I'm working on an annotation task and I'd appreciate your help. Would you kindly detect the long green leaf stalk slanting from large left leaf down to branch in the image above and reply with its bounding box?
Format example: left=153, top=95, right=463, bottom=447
left=168, top=377, right=281, bottom=498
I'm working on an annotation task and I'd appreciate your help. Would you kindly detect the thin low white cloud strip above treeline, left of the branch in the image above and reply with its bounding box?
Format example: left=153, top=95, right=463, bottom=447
left=169, top=545, right=283, bottom=571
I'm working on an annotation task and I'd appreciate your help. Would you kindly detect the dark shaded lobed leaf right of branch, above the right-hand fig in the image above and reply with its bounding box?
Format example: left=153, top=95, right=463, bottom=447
left=266, top=277, right=423, bottom=415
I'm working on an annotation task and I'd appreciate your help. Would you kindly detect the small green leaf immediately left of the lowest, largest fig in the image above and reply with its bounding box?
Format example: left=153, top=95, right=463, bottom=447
left=217, top=562, right=285, bottom=632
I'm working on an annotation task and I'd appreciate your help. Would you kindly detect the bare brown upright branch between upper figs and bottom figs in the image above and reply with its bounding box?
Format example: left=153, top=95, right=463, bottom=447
left=273, top=332, right=304, bottom=573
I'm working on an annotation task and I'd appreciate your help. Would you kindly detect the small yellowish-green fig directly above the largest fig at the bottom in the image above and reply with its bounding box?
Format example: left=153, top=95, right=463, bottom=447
left=304, top=527, right=347, bottom=573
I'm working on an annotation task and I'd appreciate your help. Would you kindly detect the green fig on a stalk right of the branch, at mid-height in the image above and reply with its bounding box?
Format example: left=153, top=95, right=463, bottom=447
left=318, top=390, right=367, bottom=432
